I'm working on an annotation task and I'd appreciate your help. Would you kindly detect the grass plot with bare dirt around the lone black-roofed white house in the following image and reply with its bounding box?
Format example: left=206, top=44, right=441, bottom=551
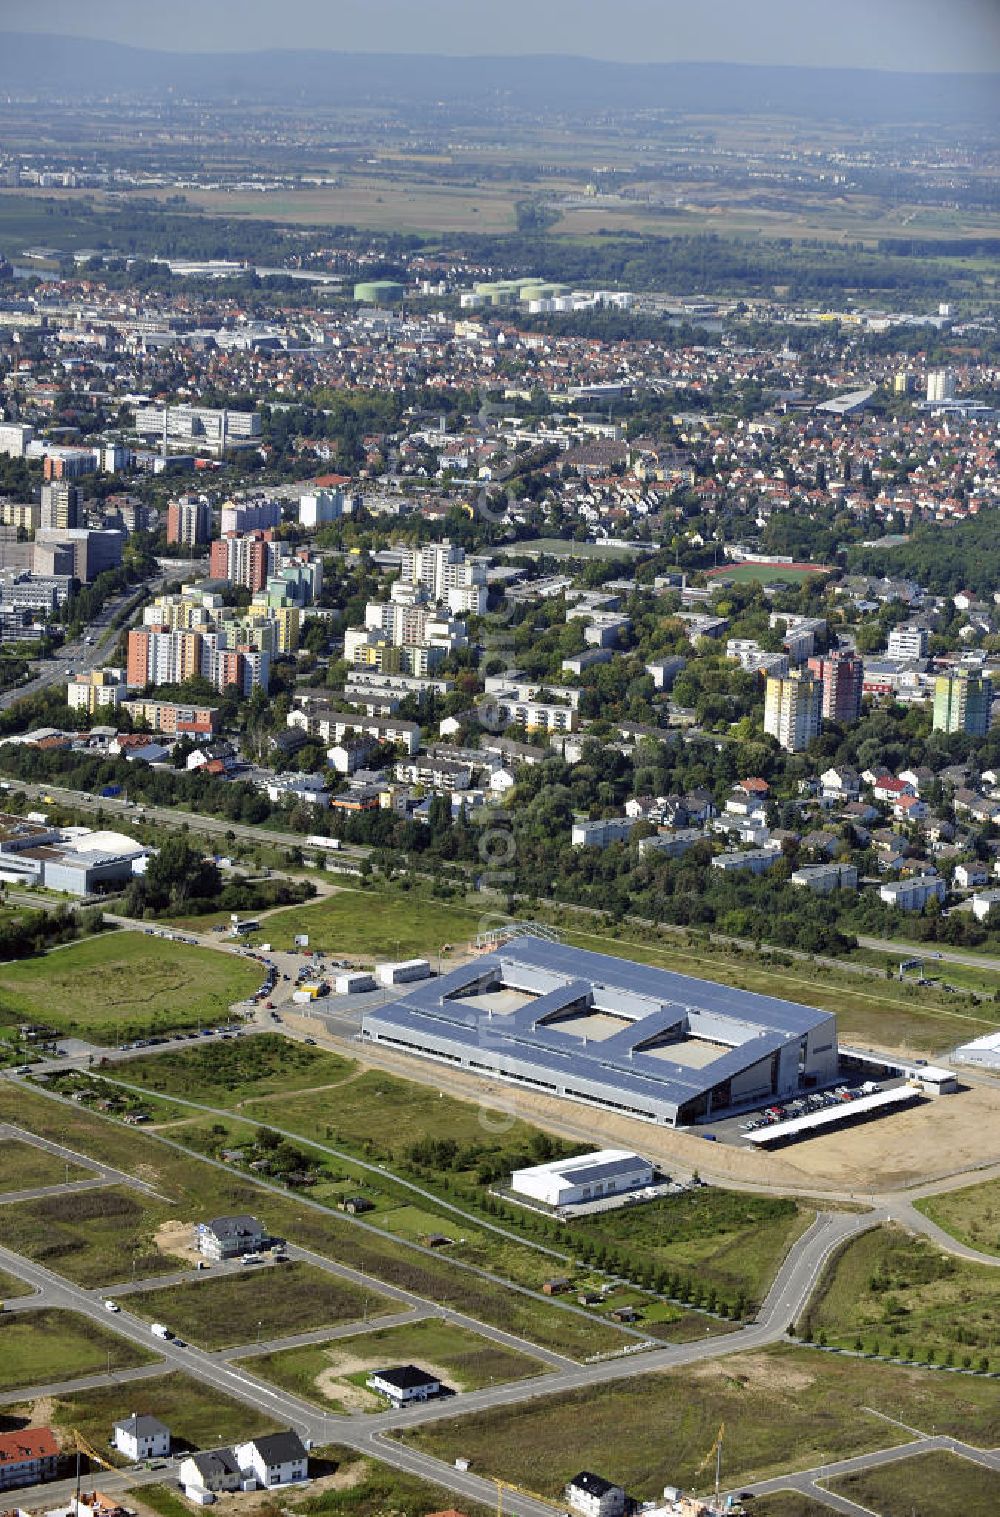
left=246, top=1318, right=546, bottom=1409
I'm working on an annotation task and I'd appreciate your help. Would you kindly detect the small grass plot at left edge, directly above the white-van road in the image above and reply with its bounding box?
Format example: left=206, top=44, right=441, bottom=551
left=0, top=1308, right=158, bottom=1389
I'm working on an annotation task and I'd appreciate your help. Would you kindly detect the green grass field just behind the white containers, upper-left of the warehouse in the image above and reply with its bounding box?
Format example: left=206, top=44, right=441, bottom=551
left=266, top=889, right=484, bottom=959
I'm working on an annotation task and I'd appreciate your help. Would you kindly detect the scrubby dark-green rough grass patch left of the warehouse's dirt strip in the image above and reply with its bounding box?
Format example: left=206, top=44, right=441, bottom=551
left=123, top=1033, right=357, bottom=1115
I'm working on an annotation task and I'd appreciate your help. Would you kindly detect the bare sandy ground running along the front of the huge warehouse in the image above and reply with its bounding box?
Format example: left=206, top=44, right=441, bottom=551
left=306, top=1018, right=1000, bottom=1200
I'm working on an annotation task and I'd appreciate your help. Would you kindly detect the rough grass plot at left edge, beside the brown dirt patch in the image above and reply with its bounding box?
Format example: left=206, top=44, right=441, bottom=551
left=0, top=1186, right=178, bottom=1286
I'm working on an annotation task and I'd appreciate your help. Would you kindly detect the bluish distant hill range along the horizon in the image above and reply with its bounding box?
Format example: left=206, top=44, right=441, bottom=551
left=0, top=32, right=1000, bottom=126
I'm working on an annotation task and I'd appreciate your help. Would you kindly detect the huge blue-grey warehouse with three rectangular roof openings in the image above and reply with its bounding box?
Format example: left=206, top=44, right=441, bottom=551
left=361, top=938, right=838, bottom=1127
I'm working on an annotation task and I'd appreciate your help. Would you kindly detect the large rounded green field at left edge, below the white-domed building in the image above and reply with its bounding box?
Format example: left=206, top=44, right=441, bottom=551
left=0, top=931, right=259, bottom=1044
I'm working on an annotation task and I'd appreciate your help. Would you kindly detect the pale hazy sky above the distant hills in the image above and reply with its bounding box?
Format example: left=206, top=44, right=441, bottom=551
left=0, top=0, right=1000, bottom=73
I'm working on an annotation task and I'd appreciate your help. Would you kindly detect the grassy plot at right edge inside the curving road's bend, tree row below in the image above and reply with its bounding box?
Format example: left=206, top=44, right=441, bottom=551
left=798, top=1227, right=1000, bottom=1368
